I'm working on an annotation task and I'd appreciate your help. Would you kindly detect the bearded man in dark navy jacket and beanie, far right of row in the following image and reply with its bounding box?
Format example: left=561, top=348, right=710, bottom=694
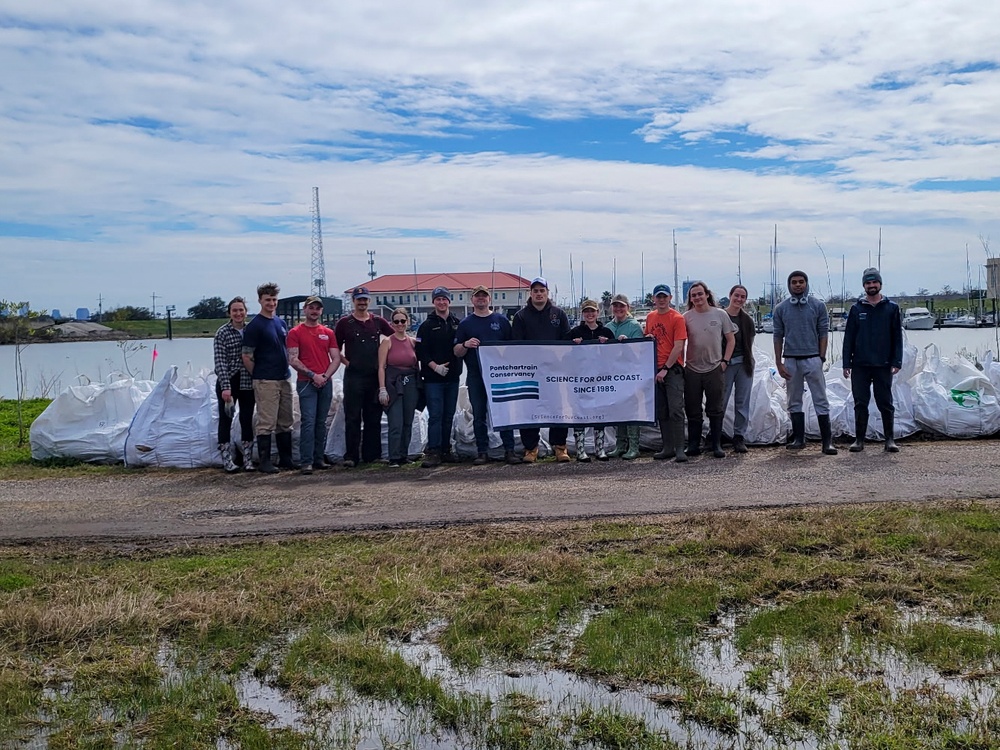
left=844, top=268, right=903, bottom=453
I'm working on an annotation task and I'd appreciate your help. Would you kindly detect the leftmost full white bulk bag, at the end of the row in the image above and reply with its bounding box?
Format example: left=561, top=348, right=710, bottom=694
left=30, top=377, right=156, bottom=463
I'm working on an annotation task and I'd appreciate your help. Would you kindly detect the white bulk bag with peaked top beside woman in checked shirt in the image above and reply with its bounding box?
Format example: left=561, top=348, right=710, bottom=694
left=125, top=365, right=222, bottom=469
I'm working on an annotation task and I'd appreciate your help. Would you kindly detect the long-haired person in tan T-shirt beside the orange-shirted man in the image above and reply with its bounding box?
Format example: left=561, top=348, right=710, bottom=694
left=684, top=281, right=736, bottom=458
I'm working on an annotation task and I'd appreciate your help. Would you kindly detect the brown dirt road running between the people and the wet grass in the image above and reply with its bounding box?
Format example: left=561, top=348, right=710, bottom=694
left=0, top=440, right=1000, bottom=543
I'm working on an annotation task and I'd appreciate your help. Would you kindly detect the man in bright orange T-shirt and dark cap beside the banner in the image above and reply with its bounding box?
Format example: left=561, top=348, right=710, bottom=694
left=646, top=284, right=687, bottom=463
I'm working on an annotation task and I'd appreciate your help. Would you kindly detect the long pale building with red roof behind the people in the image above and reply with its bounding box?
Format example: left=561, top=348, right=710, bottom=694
left=344, top=271, right=531, bottom=322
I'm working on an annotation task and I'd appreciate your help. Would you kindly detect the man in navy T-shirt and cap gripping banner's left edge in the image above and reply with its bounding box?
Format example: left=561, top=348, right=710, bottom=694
left=454, top=286, right=521, bottom=466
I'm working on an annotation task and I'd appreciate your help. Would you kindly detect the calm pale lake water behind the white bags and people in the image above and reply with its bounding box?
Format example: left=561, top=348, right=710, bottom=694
left=0, top=328, right=997, bottom=398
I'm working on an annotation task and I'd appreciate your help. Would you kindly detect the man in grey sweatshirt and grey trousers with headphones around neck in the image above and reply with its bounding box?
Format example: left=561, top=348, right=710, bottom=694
left=773, top=271, right=837, bottom=456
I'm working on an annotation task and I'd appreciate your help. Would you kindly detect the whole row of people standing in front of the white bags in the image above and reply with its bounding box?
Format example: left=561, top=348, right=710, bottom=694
left=214, top=268, right=903, bottom=474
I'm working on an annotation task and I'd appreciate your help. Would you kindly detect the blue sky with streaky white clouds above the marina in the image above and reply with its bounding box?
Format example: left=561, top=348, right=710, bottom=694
left=0, top=0, right=1000, bottom=314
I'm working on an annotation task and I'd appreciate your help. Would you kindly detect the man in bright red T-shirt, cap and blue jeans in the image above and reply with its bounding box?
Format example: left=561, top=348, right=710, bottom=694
left=286, top=297, right=340, bottom=474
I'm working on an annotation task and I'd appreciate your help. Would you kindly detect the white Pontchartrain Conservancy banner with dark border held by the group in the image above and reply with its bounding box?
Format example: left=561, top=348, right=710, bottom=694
left=479, top=339, right=656, bottom=429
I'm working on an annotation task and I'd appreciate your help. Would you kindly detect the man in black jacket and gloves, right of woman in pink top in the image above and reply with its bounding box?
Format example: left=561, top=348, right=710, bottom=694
left=417, top=286, right=462, bottom=469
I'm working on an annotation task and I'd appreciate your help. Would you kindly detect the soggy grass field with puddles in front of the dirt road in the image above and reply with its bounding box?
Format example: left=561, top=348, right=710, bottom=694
left=0, top=502, right=1000, bottom=750
